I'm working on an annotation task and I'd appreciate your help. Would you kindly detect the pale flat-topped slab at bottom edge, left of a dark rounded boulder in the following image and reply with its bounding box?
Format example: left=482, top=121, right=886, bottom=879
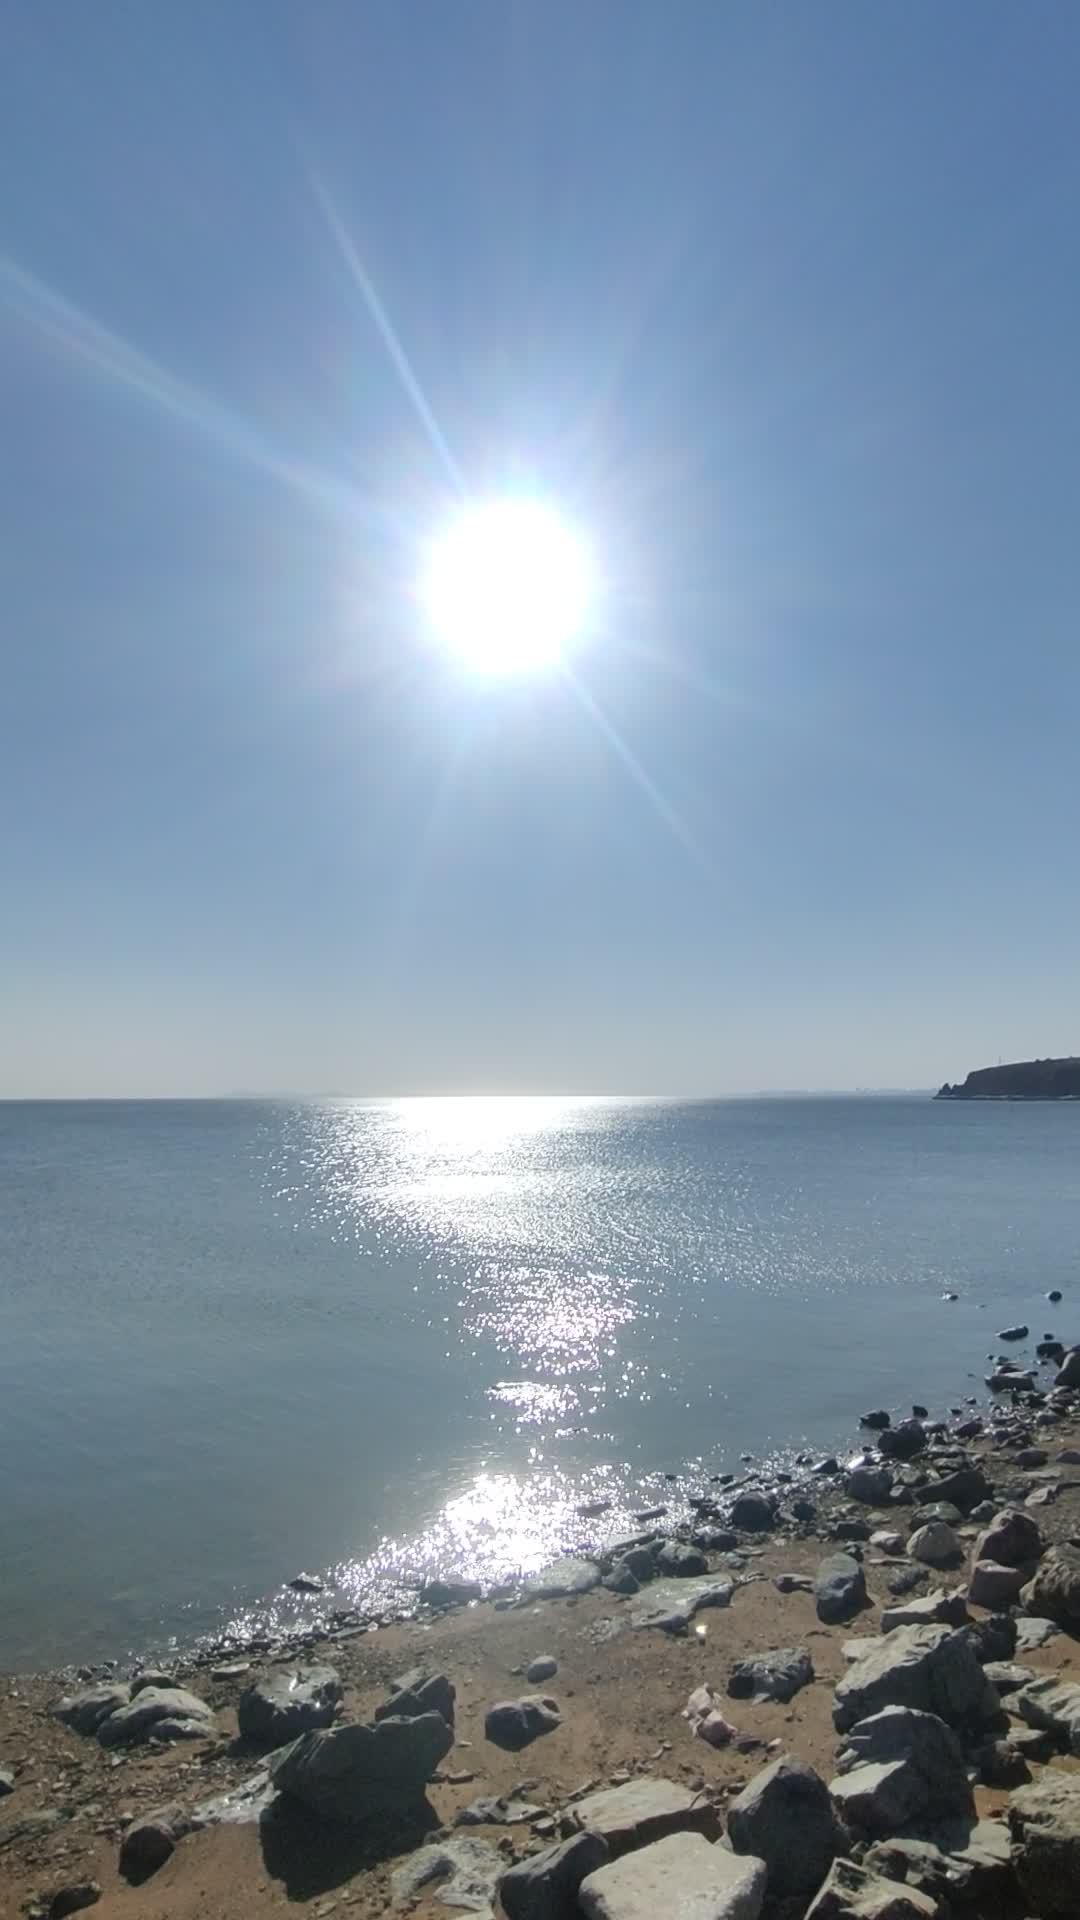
left=578, top=1834, right=767, bottom=1920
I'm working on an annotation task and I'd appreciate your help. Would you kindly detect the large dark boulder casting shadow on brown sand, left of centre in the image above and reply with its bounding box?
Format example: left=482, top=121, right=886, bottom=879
left=269, top=1713, right=454, bottom=1822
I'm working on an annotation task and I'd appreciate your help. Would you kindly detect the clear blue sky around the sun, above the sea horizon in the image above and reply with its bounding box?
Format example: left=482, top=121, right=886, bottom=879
left=0, top=0, right=1080, bottom=1094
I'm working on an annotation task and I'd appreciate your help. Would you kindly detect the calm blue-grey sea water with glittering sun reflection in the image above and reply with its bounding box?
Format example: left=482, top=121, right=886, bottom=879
left=0, top=1098, right=1080, bottom=1667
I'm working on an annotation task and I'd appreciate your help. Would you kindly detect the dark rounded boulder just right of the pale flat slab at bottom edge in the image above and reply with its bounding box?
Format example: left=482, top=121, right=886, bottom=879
left=728, top=1753, right=844, bottom=1899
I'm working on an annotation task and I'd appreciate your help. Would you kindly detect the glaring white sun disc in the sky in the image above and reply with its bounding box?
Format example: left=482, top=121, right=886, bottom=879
left=421, top=499, right=592, bottom=674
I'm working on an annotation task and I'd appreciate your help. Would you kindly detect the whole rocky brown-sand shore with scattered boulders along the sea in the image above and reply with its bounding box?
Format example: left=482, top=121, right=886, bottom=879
left=0, top=1329, right=1080, bottom=1920
